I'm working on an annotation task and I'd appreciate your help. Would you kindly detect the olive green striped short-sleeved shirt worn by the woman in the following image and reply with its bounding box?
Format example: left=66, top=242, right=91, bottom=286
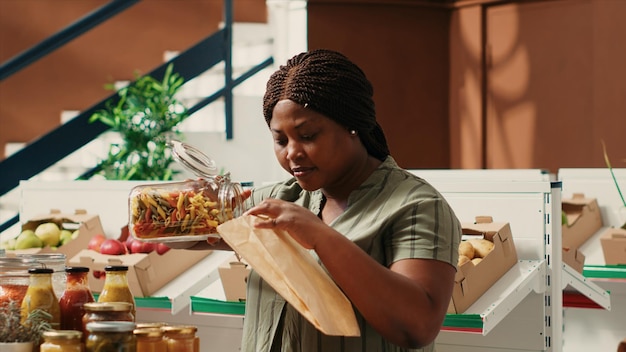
left=241, top=157, right=461, bottom=352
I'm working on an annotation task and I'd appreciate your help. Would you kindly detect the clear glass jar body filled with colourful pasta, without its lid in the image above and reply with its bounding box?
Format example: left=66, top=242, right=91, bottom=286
left=129, top=186, right=233, bottom=240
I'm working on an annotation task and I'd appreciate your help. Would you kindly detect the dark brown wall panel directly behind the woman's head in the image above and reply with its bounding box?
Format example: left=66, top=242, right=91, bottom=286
left=308, top=3, right=450, bottom=168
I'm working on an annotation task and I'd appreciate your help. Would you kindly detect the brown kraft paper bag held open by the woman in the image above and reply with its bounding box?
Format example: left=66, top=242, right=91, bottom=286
left=217, top=215, right=360, bottom=336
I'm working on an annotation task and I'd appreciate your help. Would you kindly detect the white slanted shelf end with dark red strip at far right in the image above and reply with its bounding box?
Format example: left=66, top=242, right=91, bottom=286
left=561, top=264, right=611, bottom=310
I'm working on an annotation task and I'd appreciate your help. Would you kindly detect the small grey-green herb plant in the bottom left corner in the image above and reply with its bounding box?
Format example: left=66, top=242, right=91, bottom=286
left=0, top=300, right=52, bottom=342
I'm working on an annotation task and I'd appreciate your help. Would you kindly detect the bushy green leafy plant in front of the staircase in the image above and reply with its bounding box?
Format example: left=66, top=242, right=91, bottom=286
left=89, top=64, right=188, bottom=180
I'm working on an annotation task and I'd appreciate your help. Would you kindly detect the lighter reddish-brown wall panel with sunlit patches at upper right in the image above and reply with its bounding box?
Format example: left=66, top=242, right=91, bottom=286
left=486, top=0, right=626, bottom=172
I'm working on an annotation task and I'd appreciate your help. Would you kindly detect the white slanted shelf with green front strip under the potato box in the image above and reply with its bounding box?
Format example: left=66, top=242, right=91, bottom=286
left=442, top=260, right=546, bottom=335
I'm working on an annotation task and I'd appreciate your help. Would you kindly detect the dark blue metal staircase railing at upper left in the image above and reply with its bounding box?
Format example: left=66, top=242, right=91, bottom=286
left=0, top=0, right=273, bottom=233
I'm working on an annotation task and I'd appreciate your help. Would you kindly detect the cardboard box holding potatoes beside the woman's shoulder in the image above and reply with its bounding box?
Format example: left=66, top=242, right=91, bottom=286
left=448, top=216, right=517, bottom=314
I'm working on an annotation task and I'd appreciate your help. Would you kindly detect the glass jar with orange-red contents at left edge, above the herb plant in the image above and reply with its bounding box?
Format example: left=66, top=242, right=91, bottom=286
left=0, top=257, right=32, bottom=306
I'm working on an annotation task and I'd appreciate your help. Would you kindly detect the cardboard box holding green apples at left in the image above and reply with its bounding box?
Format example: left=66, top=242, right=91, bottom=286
left=7, top=209, right=104, bottom=262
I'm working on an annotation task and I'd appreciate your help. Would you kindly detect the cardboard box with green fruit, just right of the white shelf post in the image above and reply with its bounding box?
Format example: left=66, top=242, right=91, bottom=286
left=561, top=193, right=602, bottom=249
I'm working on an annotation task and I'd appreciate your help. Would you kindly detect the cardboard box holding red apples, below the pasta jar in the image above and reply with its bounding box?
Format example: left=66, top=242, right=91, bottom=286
left=69, top=249, right=211, bottom=297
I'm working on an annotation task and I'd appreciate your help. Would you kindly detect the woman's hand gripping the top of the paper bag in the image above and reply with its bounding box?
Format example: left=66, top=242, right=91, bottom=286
left=244, top=198, right=328, bottom=249
